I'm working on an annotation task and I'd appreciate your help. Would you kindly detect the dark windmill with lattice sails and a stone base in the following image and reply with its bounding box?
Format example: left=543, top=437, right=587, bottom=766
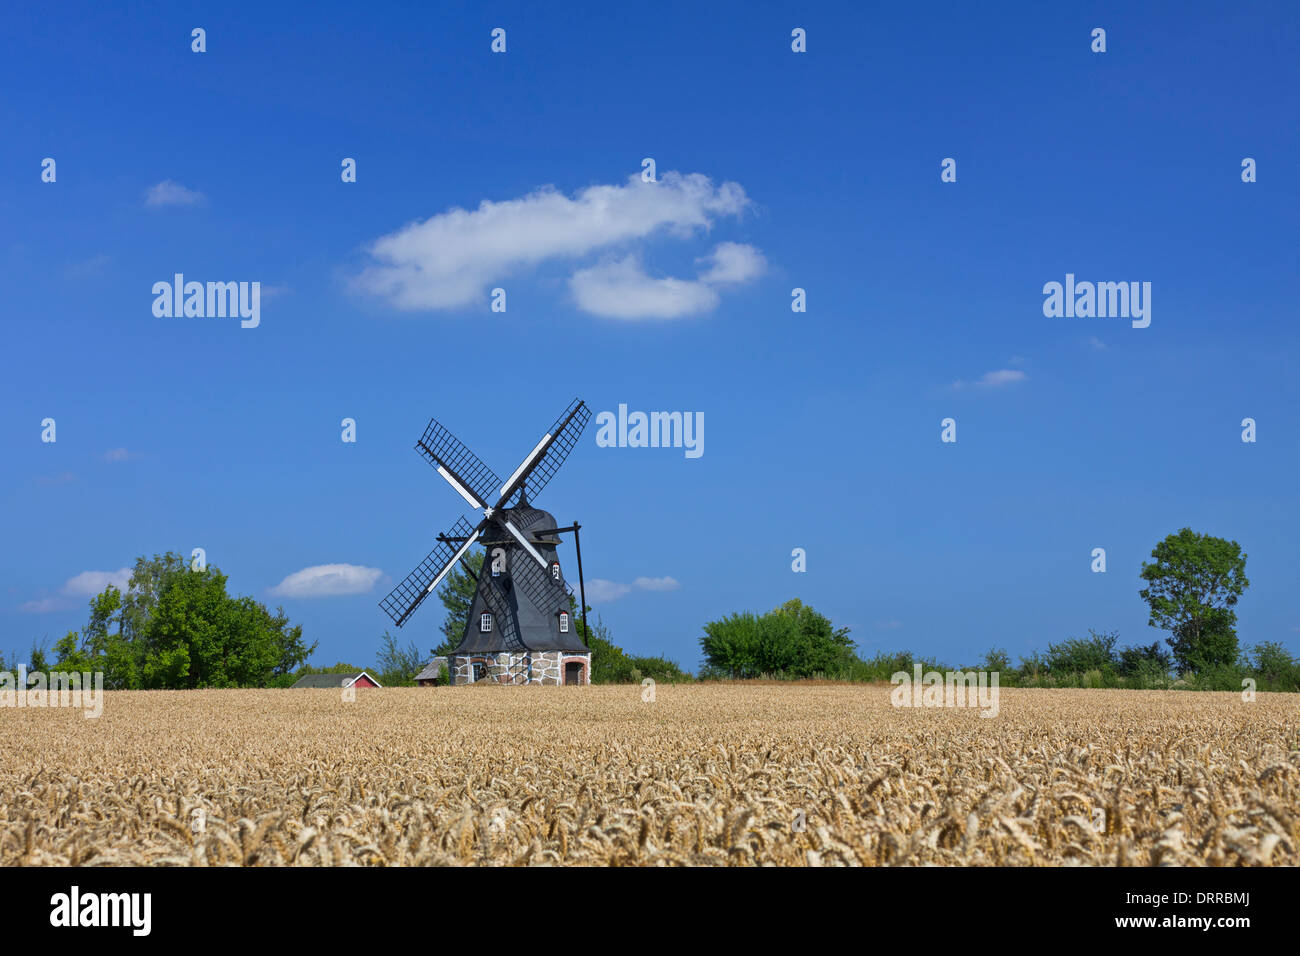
left=380, top=398, right=592, bottom=684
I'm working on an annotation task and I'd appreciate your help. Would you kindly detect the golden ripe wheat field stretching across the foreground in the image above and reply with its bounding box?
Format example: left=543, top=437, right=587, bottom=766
left=0, top=684, right=1300, bottom=866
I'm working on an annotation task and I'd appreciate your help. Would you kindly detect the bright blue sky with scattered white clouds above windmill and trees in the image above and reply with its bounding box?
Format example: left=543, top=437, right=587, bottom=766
left=0, top=3, right=1300, bottom=667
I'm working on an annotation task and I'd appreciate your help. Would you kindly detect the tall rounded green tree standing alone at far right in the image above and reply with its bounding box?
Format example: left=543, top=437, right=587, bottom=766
left=1140, top=528, right=1251, bottom=671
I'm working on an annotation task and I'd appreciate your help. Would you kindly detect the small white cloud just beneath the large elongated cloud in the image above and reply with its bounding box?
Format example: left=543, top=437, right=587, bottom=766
left=569, top=256, right=719, bottom=319
